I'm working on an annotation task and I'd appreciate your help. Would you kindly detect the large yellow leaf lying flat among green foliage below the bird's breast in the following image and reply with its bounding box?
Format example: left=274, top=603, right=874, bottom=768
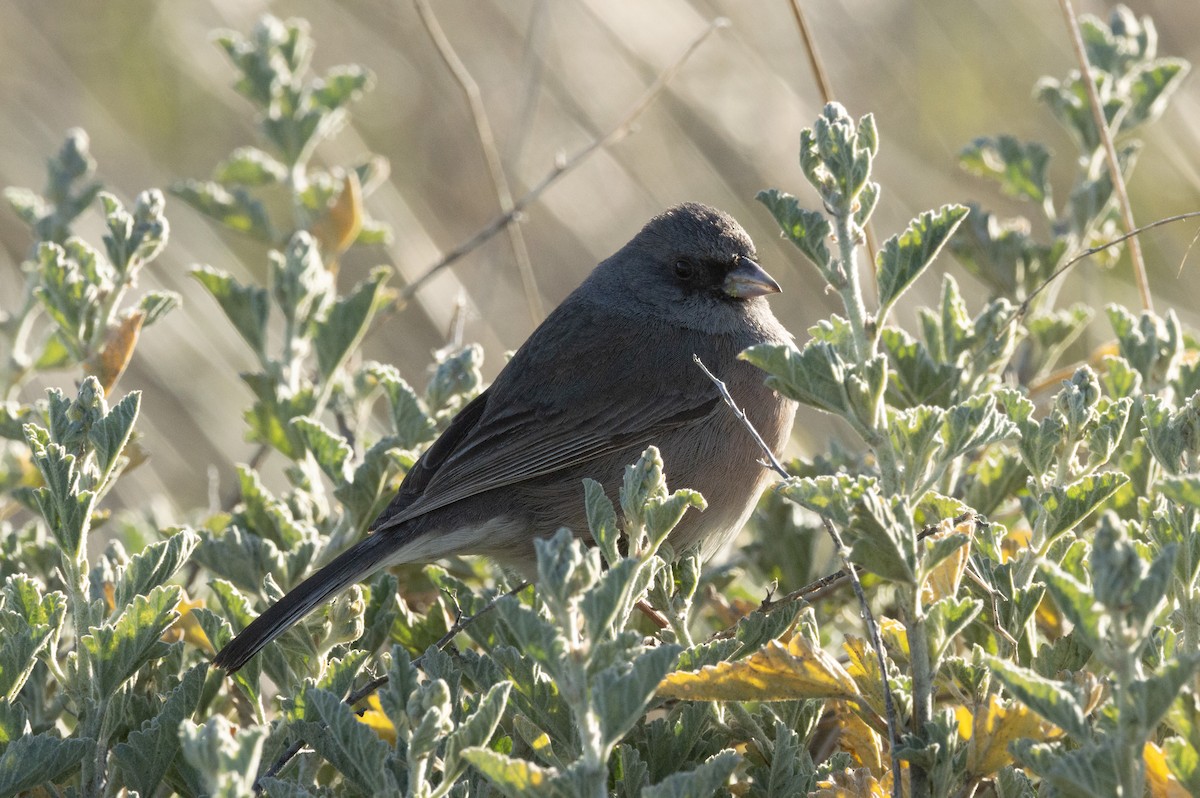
left=659, top=635, right=860, bottom=701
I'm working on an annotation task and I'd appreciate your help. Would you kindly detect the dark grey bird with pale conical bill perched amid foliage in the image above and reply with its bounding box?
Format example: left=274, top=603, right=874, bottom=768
left=214, top=203, right=796, bottom=673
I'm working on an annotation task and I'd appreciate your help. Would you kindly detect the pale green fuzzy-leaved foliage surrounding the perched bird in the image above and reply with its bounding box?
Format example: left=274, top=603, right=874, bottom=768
left=0, top=8, right=1200, bottom=798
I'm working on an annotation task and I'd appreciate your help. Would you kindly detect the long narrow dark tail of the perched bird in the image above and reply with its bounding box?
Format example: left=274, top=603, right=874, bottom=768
left=212, top=533, right=388, bottom=673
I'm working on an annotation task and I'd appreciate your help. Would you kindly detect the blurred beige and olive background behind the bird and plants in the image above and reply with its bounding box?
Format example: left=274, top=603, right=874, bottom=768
left=0, top=0, right=1200, bottom=520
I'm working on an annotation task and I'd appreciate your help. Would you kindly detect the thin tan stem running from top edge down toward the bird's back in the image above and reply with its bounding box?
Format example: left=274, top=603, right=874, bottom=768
left=414, top=0, right=546, bottom=324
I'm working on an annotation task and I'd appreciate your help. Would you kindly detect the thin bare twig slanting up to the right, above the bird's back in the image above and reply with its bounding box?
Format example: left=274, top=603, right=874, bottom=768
left=400, top=18, right=728, bottom=302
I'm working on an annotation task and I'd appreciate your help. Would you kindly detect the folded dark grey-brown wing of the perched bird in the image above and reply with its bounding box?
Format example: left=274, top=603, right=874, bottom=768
left=374, top=302, right=720, bottom=533
